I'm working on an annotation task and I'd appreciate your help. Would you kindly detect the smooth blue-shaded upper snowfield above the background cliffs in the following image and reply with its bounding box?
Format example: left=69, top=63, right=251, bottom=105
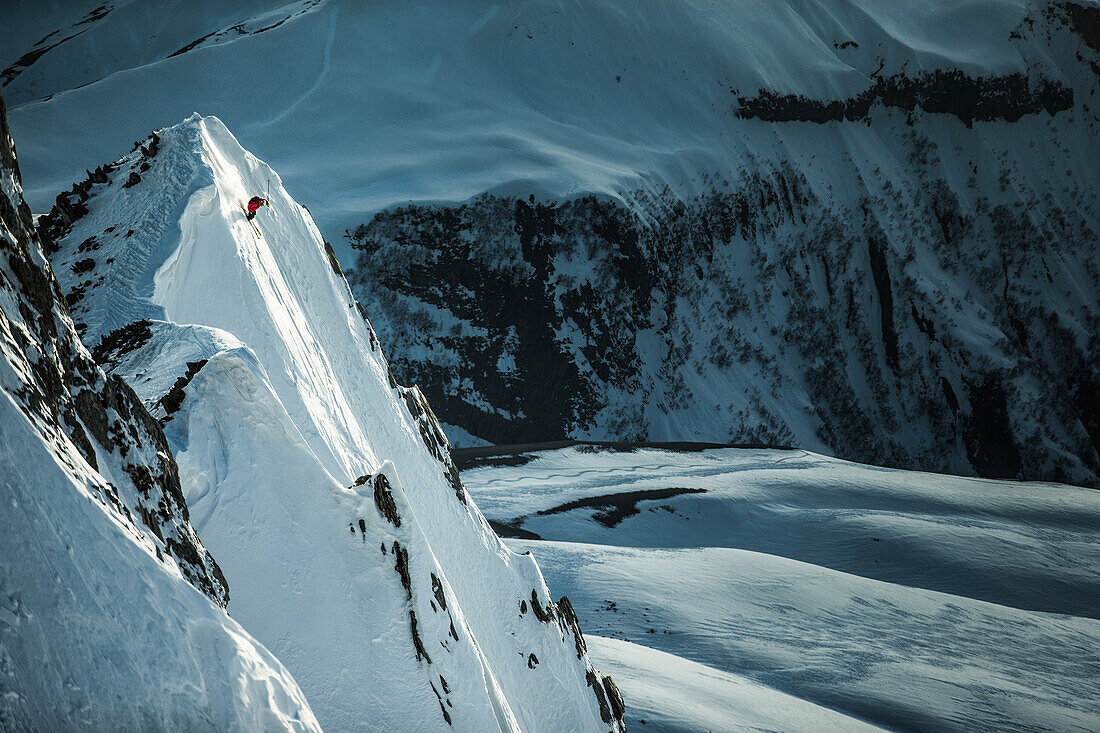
left=0, top=0, right=1082, bottom=259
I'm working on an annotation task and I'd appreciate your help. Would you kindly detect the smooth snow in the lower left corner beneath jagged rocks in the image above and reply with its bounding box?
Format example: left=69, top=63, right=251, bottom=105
left=0, top=391, right=320, bottom=731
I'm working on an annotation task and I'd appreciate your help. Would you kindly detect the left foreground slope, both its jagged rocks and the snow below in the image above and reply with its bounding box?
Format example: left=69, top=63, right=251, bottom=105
left=0, top=91, right=319, bottom=731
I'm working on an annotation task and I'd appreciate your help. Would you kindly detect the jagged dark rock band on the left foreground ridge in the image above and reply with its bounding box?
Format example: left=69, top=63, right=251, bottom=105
left=0, top=89, right=229, bottom=606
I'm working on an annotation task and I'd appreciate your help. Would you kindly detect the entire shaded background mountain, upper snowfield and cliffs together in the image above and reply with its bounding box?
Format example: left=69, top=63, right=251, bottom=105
left=0, top=0, right=1100, bottom=484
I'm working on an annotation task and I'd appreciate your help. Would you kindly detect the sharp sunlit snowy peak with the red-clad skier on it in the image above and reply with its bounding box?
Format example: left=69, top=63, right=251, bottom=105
left=39, top=116, right=623, bottom=731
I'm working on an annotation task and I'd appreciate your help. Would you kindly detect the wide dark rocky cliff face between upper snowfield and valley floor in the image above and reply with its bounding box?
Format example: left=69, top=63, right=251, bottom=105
left=350, top=162, right=1100, bottom=483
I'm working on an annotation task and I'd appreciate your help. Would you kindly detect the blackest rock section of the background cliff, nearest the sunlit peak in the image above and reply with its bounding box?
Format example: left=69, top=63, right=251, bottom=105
left=350, top=193, right=648, bottom=442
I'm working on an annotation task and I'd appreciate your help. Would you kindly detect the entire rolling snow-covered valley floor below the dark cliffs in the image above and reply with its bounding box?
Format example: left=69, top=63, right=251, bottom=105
left=463, top=448, right=1100, bottom=731
